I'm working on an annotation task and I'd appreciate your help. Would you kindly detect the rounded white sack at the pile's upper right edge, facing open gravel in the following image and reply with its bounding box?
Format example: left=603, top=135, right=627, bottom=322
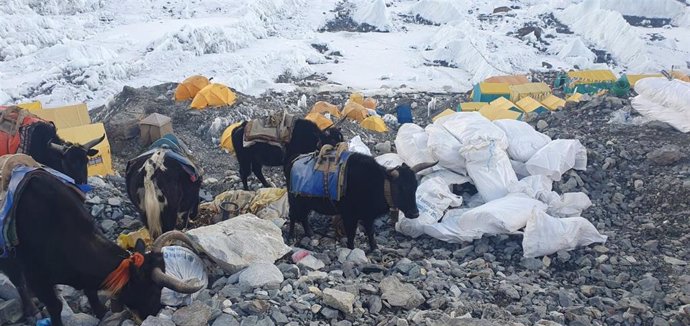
left=526, top=139, right=587, bottom=181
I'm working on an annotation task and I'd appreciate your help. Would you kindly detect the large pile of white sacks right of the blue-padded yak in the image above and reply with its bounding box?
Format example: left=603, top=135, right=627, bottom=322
left=362, top=112, right=606, bottom=257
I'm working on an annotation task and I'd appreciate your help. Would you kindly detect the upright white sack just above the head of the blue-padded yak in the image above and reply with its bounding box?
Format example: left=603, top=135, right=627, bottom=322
left=395, top=123, right=436, bottom=166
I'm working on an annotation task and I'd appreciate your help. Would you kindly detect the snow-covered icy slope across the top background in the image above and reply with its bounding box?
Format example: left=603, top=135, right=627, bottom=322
left=0, top=0, right=690, bottom=107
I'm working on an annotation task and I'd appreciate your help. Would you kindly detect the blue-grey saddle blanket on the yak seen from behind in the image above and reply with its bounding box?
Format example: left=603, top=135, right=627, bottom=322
left=126, top=134, right=203, bottom=182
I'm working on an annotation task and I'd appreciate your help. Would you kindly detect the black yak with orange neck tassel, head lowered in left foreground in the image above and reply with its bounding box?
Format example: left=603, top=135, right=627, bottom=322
left=0, top=169, right=203, bottom=326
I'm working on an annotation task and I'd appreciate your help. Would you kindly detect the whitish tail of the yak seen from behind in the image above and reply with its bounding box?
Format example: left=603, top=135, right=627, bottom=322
left=142, top=151, right=165, bottom=239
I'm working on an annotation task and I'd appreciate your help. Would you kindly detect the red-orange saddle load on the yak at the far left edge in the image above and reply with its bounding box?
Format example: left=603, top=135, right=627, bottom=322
left=0, top=106, right=44, bottom=155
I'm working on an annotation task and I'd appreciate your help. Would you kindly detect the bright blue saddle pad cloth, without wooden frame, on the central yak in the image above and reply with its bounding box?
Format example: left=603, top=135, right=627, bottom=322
left=290, top=151, right=352, bottom=201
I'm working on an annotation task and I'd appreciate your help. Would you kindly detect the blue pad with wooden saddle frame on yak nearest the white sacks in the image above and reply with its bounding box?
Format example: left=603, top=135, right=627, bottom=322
left=290, top=143, right=352, bottom=201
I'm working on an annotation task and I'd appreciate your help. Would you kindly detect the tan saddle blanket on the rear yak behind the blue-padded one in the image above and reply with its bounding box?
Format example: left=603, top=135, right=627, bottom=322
left=243, top=111, right=297, bottom=147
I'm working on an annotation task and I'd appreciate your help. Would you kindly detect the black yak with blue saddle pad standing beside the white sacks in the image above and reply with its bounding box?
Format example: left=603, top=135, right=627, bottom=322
left=288, top=153, right=430, bottom=251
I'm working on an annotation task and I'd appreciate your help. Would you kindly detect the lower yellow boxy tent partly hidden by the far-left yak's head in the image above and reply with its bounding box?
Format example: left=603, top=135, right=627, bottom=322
left=57, top=123, right=113, bottom=176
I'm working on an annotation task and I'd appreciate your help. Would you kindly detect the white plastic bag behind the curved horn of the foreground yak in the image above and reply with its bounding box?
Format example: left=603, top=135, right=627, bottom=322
left=161, top=246, right=208, bottom=307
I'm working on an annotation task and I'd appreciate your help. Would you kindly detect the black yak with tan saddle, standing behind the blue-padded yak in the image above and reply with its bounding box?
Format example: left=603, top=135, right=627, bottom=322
left=232, top=119, right=343, bottom=190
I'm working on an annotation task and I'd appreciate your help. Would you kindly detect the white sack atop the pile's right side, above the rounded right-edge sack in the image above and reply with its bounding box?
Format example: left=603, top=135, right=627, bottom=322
left=493, top=119, right=551, bottom=162
